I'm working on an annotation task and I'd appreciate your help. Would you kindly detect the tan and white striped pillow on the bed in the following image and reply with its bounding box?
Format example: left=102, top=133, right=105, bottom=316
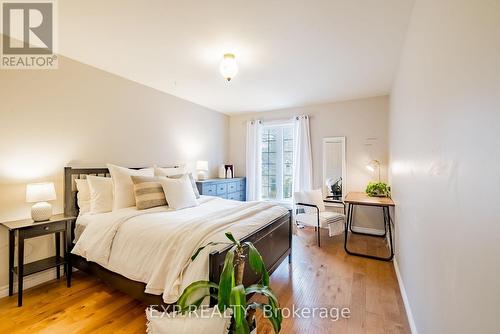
left=131, top=176, right=167, bottom=210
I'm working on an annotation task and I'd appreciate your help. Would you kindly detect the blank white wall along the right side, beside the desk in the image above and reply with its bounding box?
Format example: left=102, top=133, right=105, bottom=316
left=390, top=0, right=500, bottom=334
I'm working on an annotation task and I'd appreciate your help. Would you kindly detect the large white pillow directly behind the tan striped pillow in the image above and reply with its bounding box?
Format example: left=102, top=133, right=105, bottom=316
left=107, top=164, right=154, bottom=210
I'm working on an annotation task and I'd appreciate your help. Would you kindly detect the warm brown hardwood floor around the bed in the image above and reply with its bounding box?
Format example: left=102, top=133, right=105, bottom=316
left=0, top=229, right=410, bottom=334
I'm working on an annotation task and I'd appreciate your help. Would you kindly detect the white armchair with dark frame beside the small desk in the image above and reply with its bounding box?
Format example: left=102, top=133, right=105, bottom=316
left=294, top=189, right=345, bottom=247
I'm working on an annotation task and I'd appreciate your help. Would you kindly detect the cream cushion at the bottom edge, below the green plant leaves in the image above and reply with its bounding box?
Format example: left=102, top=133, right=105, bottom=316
left=146, top=306, right=231, bottom=334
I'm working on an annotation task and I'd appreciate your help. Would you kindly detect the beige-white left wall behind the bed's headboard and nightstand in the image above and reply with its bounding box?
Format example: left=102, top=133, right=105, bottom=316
left=0, top=57, right=229, bottom=288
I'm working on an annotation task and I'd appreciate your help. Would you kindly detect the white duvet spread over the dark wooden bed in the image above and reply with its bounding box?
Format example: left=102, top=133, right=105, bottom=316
left=72, top=196, right=287, bottom=303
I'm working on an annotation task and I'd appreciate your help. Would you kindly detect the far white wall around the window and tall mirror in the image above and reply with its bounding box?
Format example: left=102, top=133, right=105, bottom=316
left=229, top=96, right=389, bottom=228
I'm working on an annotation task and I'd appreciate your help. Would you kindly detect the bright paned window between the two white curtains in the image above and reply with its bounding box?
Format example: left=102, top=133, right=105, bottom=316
left=262, top=124, right=293, bottom=201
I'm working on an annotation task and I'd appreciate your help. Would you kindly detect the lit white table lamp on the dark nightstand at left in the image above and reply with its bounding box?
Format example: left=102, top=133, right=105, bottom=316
left=26, top=182, right=56, bottom=222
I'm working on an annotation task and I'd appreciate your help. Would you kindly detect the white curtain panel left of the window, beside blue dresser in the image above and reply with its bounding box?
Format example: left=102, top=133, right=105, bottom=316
left=246, top=120, right=262, bottom=201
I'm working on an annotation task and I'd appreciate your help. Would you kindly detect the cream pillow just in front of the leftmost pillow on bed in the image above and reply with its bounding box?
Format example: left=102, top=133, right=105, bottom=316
left=87, top=175, right=113, bottom=214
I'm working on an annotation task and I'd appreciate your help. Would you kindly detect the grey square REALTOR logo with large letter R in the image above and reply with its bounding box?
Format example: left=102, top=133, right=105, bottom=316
left=1, top=0, right=57, bottom=69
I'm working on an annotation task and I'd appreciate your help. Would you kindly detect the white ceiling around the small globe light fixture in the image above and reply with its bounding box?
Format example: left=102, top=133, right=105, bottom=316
left=58, top=0, right=413, bottom=114
